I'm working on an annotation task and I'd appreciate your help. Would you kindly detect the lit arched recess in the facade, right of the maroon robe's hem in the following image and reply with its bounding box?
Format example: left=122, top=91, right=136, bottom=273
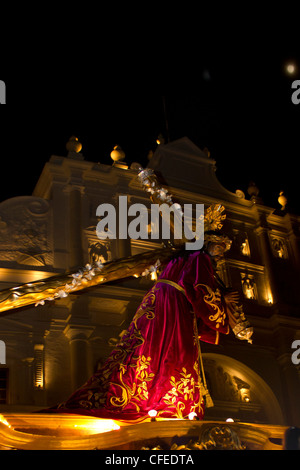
left=203, top=353, right=284, bottom=424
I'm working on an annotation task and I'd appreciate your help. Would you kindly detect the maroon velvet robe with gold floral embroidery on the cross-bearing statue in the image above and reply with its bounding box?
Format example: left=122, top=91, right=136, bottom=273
left=56, top=251, right=229, bottom=420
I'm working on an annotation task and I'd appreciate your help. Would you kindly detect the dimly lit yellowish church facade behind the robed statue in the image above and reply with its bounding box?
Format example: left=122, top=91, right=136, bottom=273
left=0, top=138, right=300, bottom=425
